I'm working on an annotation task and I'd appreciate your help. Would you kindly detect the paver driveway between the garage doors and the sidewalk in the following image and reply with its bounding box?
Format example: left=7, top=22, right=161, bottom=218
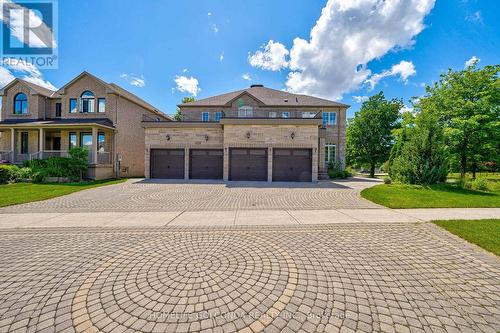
left=0, top=178, right=381, bottom=213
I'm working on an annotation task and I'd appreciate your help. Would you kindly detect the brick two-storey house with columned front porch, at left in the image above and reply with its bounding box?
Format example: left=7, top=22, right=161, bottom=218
left=0, top=72, right=170, bottom=179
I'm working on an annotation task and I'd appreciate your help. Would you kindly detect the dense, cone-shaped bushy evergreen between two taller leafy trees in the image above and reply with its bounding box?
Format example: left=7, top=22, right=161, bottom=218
left=389, top=110, right=448, bottom=185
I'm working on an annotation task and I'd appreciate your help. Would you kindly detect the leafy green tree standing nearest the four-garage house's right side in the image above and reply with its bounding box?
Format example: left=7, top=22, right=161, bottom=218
left=347, top=92, right=403, bottom=177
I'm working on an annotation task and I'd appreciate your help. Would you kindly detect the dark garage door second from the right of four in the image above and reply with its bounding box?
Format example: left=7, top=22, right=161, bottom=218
left=229, top=148, right=267, bottom=181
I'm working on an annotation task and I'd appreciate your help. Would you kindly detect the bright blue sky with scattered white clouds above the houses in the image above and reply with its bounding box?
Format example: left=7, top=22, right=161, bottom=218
left=0, top=0, right=500, bottom=117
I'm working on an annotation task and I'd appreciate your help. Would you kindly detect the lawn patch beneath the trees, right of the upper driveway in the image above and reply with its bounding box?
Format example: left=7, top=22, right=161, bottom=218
left=361, top=184, right=500, bottom=208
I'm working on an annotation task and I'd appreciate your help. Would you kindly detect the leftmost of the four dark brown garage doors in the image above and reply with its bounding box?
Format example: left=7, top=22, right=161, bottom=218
left=151, top=149, right=184, bottom=179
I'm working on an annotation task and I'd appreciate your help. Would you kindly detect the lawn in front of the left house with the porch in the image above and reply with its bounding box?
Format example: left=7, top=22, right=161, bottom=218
left=0, top=179, right=126, bottom=207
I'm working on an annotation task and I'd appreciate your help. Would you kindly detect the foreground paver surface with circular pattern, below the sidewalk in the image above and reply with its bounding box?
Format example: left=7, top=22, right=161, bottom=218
left=0, top=223, right=500, bottom=332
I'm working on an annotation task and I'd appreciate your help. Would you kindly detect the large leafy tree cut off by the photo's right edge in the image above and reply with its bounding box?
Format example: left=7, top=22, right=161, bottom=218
left=420, top=62, right=500, bottom=178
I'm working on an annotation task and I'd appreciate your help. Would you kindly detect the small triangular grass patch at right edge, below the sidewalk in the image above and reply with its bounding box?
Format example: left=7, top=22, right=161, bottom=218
left=433, top=219, right=500, bottom=256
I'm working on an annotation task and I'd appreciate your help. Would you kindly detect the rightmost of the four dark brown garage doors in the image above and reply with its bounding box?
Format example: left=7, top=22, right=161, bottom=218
left=273, top=149, right=312, bottom=182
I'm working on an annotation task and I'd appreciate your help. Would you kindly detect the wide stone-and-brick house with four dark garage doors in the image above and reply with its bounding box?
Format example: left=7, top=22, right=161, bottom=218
left=143, top=85, right=349, bottom=182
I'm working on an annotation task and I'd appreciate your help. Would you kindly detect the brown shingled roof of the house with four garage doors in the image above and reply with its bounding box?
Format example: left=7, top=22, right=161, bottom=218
left=179, top=85, right=349, bottom=107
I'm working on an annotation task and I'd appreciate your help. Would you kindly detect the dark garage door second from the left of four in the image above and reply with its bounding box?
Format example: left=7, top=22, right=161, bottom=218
left=189, top=149, right=224, bottom=179
